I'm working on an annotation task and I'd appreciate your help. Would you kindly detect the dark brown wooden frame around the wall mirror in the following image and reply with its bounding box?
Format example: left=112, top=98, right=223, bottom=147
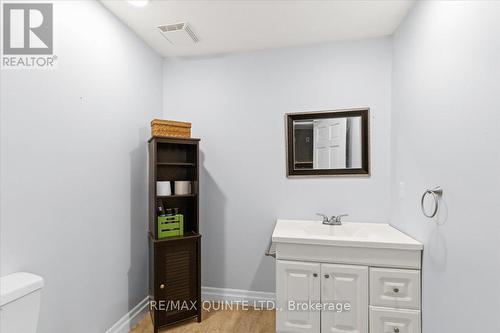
left=285, top=108, right=370, bottom=177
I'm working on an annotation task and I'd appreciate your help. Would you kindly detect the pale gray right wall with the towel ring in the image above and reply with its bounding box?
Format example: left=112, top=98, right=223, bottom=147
left=392, top=1, right=500, bottom=333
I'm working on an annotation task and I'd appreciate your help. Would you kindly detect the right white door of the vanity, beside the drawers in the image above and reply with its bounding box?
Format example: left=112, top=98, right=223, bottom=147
left=321, top=264, right=368, bottom=333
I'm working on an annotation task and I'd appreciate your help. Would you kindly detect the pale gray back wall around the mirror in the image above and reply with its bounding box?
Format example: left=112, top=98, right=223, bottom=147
left=164, top=38, right=392, bottom=292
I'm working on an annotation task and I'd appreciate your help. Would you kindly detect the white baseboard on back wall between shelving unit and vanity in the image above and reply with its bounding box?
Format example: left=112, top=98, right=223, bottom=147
left=201, top=287, right=276, bottom=304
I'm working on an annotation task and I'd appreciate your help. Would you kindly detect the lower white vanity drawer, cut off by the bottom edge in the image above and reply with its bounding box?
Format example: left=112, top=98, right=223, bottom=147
left=370, top=306, right=421, bottom=333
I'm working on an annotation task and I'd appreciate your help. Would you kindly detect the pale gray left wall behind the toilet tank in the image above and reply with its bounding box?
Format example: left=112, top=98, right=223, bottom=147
left=0, top=1, right=163, bottom=333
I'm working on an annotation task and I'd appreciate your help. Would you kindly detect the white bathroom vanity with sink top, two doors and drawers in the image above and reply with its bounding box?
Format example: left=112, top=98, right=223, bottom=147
left=272, top=220, right=423, bottom=333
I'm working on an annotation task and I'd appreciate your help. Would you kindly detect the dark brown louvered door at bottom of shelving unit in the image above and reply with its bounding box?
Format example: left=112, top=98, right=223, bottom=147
left=154, top=238, right=201, bottom=327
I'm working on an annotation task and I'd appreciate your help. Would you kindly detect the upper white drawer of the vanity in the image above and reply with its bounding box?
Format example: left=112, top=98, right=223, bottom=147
left=370, top=268, right=420, bottom=310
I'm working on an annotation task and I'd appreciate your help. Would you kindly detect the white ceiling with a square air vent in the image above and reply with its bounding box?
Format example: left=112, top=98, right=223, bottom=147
left=101, top=0, right=414, bottom=57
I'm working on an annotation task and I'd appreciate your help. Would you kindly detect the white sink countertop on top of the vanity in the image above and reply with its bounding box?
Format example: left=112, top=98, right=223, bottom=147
left=273, top=219, right=423, bottom=250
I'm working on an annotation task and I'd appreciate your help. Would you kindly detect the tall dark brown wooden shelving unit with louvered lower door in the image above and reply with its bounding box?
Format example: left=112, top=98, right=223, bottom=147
left=149, top=137, right=201, bottom=333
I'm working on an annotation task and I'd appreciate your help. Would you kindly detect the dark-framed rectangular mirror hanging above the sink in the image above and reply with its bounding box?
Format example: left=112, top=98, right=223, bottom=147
left=286, top=108, right=370, bottom=176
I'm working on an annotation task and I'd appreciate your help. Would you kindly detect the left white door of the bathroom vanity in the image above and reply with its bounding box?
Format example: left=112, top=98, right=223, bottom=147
left=276, top=260, right=321, bottom=333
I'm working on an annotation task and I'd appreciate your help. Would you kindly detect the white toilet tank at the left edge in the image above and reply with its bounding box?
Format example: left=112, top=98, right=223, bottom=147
left=0, top=272, right=43, bottom=333
